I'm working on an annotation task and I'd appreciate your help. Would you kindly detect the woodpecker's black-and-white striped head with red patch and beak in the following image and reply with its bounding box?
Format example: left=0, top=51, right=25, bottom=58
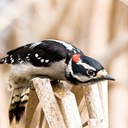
left=66, top=54, right=114, bottom=85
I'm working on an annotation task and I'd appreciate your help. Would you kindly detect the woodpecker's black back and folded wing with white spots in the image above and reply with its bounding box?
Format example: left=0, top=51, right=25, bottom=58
left=1, top=40, right=83, bottom=66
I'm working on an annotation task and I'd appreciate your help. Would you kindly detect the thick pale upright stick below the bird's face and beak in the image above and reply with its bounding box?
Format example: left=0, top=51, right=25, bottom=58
left=85, top=84, right=104, bottom=128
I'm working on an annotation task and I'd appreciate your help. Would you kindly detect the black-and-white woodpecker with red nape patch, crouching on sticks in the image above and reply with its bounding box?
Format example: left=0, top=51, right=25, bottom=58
left=0, top=39, right=115, bottom=123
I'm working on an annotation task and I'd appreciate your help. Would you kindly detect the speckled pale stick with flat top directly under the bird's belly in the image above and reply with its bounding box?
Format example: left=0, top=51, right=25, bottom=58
left=32, top=78, right=66, bottom=128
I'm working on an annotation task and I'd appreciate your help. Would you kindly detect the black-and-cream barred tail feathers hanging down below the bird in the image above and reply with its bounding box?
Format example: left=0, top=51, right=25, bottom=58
left=9, top=87, right=29, bottom=123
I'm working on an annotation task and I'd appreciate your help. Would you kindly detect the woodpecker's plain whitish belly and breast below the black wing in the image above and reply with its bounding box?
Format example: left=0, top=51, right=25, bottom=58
left=11, top=61, right=67, bottom=80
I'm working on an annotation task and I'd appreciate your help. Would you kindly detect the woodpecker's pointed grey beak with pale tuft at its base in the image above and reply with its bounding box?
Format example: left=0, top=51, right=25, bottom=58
left=97, top=69, right=115, bottom=81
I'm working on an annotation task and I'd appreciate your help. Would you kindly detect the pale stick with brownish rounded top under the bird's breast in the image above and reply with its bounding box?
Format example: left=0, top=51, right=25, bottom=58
left=52, top=83, right=82, bottom=128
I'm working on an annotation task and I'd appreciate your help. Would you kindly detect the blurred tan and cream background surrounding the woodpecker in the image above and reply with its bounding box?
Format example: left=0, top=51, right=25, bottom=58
left=0, top=0, right=128, bottom=128
